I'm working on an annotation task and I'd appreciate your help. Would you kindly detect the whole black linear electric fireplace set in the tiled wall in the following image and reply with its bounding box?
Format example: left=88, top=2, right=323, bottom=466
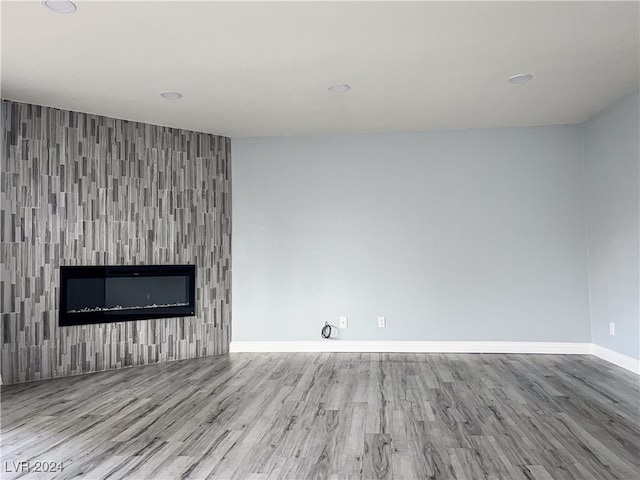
left=59, top=265, right=196, bottom=326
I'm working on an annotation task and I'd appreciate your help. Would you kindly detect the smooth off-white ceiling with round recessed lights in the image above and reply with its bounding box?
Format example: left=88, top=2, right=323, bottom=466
left=1, top=0, right=640, bottom=137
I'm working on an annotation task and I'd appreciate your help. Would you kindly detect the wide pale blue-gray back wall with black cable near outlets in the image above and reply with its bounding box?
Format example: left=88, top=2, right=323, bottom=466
left=232, top=125, right=590, bottom=342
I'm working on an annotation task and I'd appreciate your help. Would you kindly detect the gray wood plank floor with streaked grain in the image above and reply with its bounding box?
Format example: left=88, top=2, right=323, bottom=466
left=1, top=353, right=640, bottom=480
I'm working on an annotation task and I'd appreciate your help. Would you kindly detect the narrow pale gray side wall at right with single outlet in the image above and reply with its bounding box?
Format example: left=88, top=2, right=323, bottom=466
left=583, top=90, right=640, bottom=358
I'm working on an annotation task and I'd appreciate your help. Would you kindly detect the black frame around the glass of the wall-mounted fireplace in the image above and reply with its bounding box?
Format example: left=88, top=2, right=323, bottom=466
left=58, top=265, right=196, bottom=327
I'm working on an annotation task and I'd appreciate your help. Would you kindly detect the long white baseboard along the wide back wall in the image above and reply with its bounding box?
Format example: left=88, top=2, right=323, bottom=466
left=229, top=340, right=592, bottom=354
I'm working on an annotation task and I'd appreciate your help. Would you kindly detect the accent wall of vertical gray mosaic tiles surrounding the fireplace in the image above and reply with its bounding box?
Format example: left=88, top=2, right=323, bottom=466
left=0, top=101, right=231, bottom=383
